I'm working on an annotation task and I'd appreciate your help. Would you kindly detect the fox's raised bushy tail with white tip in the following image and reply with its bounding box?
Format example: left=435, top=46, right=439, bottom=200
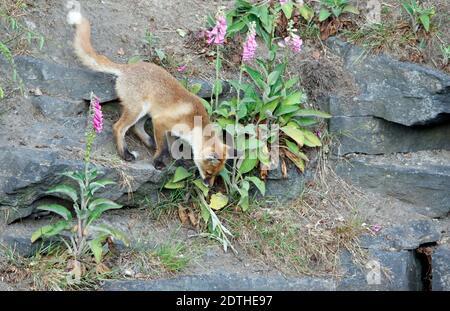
left=67, top=1, right=124, bottom=75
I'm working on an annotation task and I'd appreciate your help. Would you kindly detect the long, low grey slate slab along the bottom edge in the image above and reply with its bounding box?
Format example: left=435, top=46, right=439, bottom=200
left=102, top=274, right=335, bottom=291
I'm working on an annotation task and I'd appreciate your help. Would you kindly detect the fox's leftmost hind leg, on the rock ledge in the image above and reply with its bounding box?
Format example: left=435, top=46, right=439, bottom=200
left=113, top=105, right=145, bottom=161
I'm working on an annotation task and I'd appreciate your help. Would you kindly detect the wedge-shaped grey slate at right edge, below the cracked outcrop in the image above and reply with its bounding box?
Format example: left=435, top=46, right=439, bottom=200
left=335, top=151, right=450, bottom=217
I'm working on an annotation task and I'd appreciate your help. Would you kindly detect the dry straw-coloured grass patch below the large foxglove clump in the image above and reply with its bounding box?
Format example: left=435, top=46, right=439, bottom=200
left=224, top=133, right=370, bottom=276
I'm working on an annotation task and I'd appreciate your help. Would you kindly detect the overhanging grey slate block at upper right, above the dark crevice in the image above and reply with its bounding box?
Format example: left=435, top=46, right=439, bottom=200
left=327, top=38, right=450, bottom=126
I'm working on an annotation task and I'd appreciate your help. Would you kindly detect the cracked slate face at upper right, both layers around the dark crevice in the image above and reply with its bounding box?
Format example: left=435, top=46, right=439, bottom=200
left=327, top=38, right=450, bottom=155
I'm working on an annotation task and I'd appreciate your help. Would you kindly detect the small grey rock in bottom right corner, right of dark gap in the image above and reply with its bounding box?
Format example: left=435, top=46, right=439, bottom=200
left=431, top=244, right=450, bottom=291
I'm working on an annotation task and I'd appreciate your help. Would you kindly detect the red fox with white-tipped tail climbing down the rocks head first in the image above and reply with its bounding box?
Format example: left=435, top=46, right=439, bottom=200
left=67, top=9, right=230, bottom=185
